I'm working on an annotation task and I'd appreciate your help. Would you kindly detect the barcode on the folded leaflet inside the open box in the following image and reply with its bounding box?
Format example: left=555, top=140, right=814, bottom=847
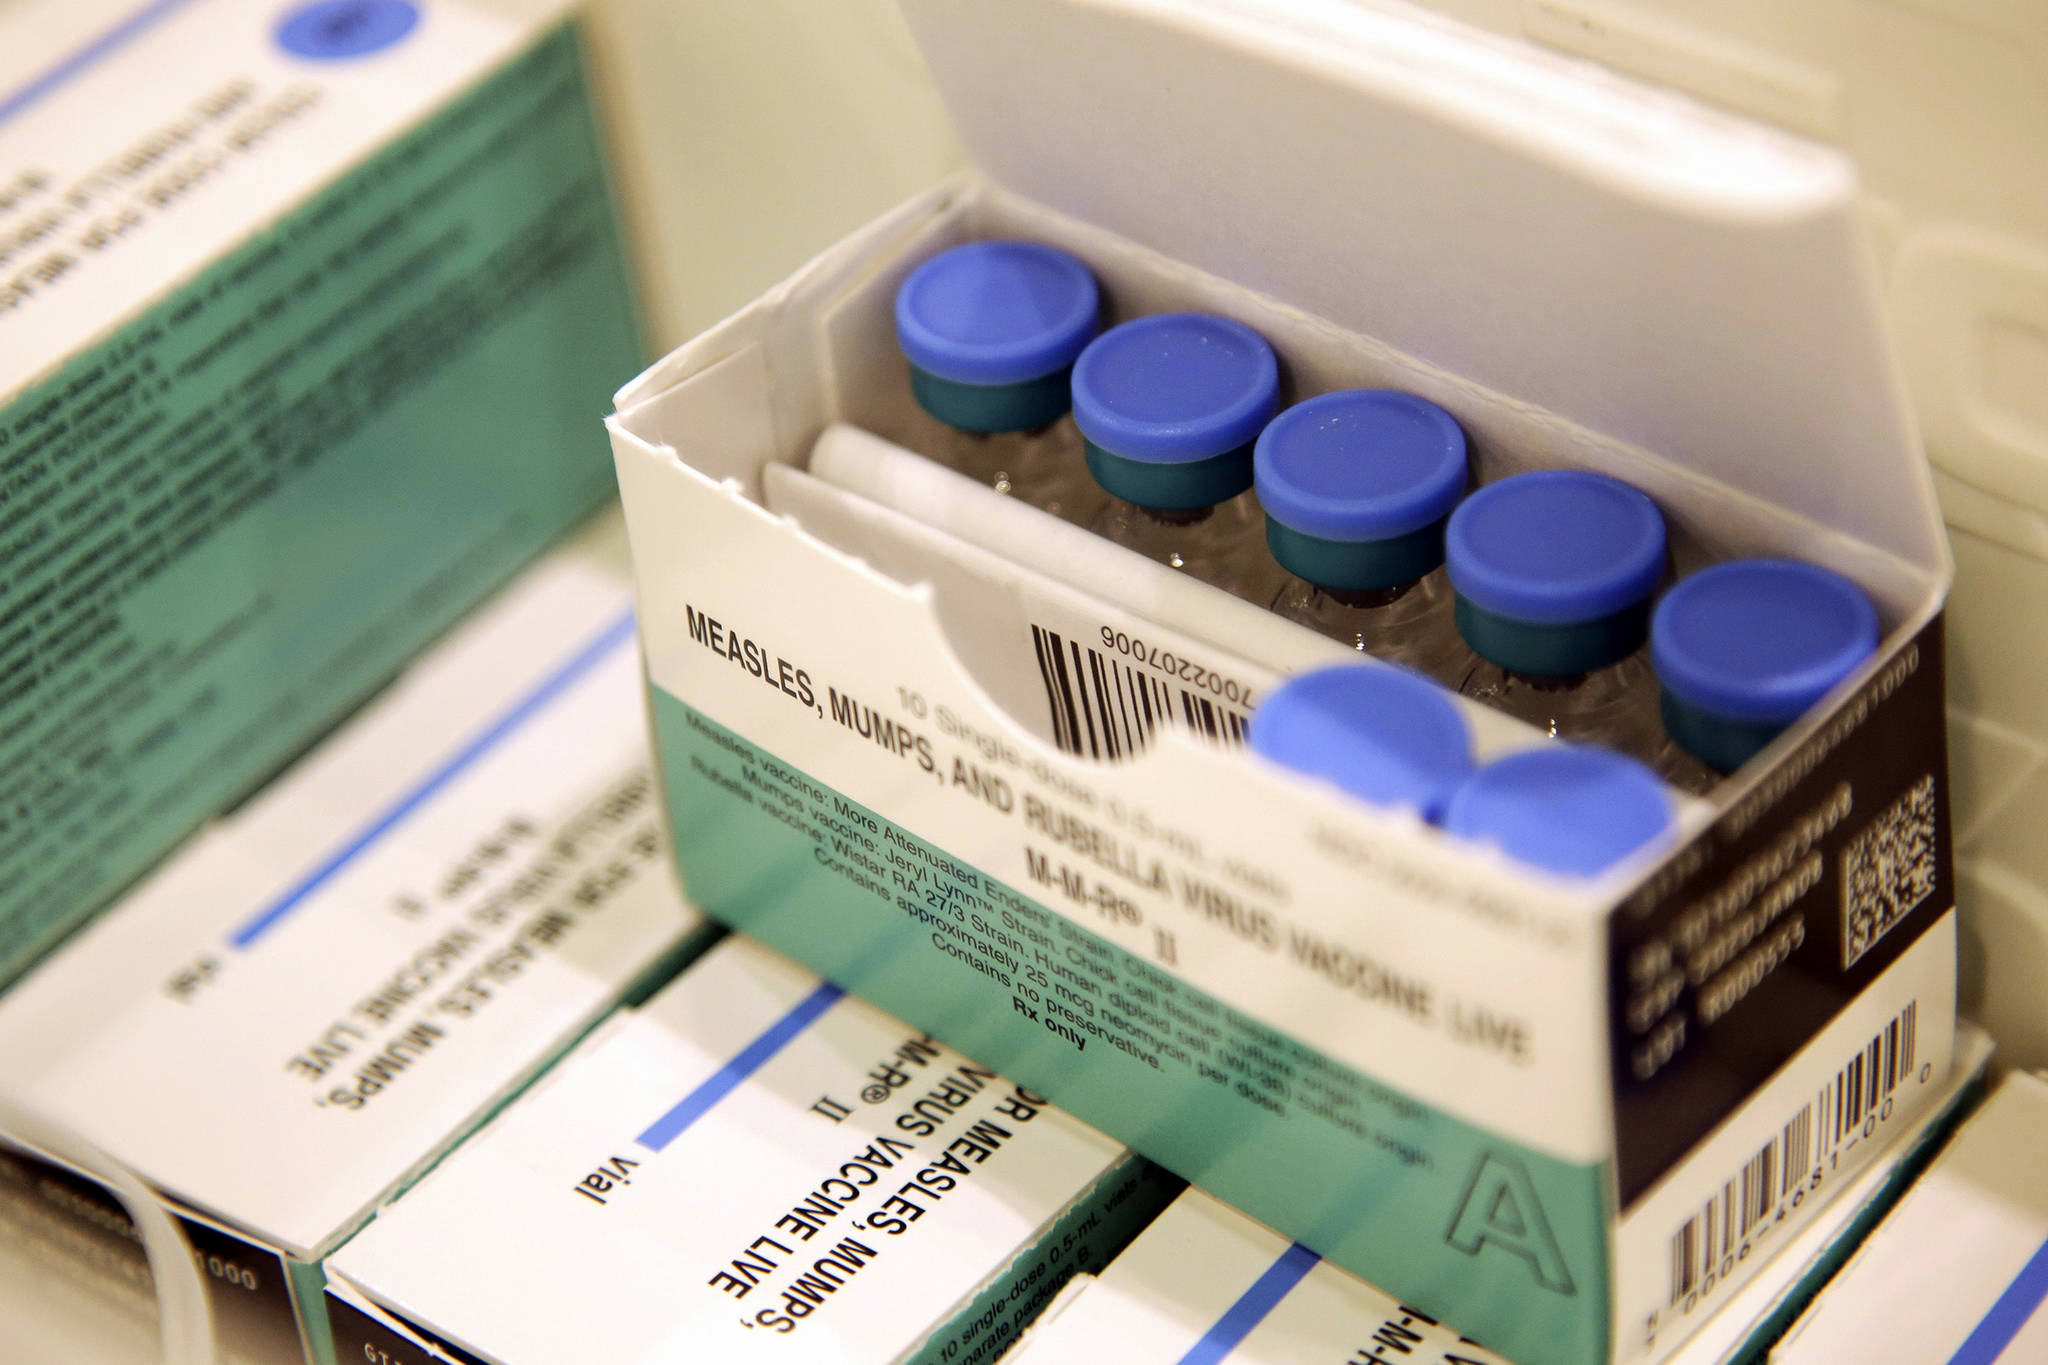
left=1030, top=626, right=1249, bottom=759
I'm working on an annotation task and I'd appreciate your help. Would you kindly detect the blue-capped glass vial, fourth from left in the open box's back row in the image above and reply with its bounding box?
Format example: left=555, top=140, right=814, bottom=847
left=1444, top=469, right=1679, bottom=769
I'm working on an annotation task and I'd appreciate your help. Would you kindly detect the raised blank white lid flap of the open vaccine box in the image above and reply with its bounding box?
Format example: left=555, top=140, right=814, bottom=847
left=905, top=0, right=1946, bottom=569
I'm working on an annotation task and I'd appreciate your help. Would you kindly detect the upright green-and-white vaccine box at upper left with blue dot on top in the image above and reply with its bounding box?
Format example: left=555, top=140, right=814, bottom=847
left=0, top=0, right=641, bottom=982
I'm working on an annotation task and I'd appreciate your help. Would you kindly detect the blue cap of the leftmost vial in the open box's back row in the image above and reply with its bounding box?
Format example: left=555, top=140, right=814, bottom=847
left=895, top=241, right=1102, bottom=385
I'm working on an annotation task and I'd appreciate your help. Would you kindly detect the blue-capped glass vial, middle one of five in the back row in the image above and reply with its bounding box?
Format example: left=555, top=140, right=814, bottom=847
left=1251, top=389, right=1470, bottom=684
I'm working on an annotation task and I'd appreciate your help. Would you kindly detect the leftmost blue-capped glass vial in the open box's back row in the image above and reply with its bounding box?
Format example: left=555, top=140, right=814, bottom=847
left=895, top=241, right=1104, bottom=524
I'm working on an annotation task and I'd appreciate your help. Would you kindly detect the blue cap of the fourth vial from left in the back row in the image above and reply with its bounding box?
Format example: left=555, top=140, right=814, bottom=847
left=1444, top=469, right=1665, bottom=626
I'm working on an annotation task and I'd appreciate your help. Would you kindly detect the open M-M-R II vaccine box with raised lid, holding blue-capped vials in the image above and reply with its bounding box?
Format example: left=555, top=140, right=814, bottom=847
left=610, top=0, right=1954, bottom=1365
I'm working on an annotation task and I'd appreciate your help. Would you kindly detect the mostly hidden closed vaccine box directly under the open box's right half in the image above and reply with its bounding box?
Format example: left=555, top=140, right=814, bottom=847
left=1004, top=1025, right=1991, bottom=1365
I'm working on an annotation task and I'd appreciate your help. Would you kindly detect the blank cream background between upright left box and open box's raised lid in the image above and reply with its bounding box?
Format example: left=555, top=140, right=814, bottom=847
left=586, top=0, right=961, bottom=349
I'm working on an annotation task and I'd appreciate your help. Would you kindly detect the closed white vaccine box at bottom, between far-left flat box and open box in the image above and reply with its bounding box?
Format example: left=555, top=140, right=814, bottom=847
left=328, top=935, right=1180, bottom=1365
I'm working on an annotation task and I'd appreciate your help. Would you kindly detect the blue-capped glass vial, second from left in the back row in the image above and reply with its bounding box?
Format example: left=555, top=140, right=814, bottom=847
left=1073, top=313, right=1280, bottom=606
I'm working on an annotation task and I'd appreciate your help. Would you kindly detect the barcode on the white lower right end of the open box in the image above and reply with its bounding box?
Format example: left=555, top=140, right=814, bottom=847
left=1669, top=1003, right=1919, bottom=1312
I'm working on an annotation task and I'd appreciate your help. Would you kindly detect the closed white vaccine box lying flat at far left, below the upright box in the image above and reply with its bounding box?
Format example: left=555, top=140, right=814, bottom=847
left=0, top=514, right=711, bottom=1361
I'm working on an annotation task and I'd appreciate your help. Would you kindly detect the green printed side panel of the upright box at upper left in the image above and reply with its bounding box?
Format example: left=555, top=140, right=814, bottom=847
left=0, top=27, right=641, bottom=982
